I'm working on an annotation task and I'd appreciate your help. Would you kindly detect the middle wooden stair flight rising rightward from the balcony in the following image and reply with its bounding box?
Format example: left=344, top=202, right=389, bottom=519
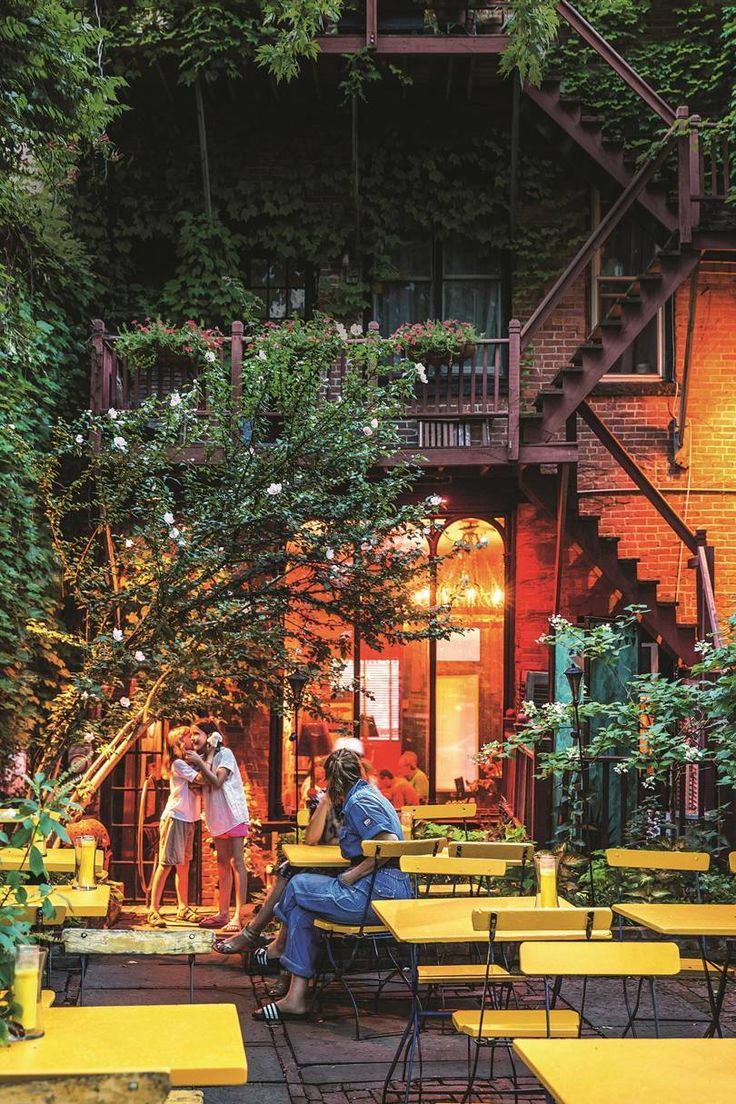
left=521, top=248, right=700, bottom=444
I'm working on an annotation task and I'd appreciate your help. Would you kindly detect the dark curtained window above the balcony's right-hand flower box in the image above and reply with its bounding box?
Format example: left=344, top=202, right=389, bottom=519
left=374, top=235, right=501, bottom=337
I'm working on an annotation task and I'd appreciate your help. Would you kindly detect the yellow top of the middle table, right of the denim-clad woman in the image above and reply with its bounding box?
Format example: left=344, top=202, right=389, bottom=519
left=373, top=896, right=591, bottom=943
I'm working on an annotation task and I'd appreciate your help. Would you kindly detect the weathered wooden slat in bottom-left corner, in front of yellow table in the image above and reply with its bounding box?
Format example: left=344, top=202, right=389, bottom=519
left=2, top=1073, right=204, bottom=1104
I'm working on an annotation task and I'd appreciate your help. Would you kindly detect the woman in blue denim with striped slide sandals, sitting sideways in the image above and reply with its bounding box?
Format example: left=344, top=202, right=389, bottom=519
left=253, top=750, right=412, bottom=1023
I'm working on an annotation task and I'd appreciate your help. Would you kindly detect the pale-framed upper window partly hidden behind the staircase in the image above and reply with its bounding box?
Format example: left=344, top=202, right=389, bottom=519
left=590, top=194, right=672, bottom=379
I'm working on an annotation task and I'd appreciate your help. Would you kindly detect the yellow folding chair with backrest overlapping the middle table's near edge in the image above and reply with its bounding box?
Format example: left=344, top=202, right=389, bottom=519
left=452, top=906, right=612, bottom=1102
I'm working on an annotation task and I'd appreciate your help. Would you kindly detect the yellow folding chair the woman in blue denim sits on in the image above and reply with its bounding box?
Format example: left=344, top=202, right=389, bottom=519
left=314, top=838, right=447, bottom=1039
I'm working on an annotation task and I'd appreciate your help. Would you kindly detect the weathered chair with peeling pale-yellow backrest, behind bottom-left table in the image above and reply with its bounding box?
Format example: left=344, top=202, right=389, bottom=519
left=62, top=927, right=214, bottom=1005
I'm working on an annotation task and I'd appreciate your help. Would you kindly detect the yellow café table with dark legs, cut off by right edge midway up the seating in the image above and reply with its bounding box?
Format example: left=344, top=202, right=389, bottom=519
left=614, top=902, right=736, bottom=1036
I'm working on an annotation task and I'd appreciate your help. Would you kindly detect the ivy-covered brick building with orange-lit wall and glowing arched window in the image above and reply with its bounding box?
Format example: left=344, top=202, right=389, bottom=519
left=87, top=0, right=736, bottom=896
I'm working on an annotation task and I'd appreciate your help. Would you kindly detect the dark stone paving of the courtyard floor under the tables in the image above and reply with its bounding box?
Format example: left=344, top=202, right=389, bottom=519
left=52, top=931, right=736, bottom=1104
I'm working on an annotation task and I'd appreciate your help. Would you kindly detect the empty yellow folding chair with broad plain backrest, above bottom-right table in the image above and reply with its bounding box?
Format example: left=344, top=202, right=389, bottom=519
left=519, top=941, right=680, bottom=1038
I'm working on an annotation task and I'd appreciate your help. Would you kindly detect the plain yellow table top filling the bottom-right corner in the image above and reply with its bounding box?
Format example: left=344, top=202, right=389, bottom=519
left=514, top=1039, right=736, bottom=1104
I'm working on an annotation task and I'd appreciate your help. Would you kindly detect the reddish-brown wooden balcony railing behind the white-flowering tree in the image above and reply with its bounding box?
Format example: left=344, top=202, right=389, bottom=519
left=90, top=320, right=520, bottom=460
